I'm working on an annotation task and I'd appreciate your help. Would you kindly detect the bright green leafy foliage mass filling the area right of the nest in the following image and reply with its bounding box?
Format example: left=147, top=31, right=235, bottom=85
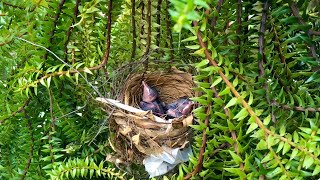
left=171, top=0, right=320, bottom=179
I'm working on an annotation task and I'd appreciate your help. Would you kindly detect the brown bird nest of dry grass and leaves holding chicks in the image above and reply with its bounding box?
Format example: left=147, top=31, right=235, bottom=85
left=100, top=70, right=195, bottom=163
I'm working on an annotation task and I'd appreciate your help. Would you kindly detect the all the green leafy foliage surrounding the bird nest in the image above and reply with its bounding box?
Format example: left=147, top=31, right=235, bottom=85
left=0, top=0, right=320, bottom=179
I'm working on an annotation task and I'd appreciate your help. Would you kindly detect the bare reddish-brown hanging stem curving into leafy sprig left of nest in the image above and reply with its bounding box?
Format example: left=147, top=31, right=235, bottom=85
left=102, top=0, right=112, bottom=69
